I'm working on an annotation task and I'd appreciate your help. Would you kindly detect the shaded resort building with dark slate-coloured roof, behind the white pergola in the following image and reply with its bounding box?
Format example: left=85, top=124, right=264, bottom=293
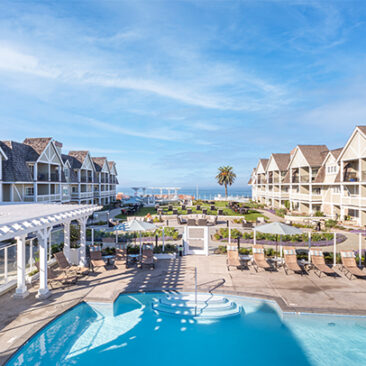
left=0, top=137, right=118, bottom=205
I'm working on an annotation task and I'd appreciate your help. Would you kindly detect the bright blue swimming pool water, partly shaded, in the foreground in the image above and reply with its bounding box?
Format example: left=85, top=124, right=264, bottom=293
left=7, top=293, right=366, bottom=366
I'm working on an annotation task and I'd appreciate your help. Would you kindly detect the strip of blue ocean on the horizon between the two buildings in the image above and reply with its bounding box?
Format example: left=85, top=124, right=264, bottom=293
left=118, top=186, right=252, bottom=200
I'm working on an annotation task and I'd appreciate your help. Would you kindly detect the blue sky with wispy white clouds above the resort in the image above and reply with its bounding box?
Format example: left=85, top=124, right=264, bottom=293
left=0, top=0, right=366, bottom=188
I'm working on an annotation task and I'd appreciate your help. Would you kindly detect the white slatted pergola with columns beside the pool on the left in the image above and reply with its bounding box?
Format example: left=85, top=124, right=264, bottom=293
left=0, top=203, right=101, bottom=298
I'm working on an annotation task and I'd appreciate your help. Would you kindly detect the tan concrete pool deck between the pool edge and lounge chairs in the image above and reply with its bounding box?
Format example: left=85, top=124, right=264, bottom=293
left=0, top=255, right=366, bottom=365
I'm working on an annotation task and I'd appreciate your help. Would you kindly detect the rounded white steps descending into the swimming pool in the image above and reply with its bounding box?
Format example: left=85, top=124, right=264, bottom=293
left=152, top=294, right=242, bottom=318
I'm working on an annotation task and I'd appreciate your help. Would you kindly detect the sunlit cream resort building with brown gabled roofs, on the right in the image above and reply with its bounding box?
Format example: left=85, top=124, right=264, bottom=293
left=249, top=126, right=366, bottom=226
